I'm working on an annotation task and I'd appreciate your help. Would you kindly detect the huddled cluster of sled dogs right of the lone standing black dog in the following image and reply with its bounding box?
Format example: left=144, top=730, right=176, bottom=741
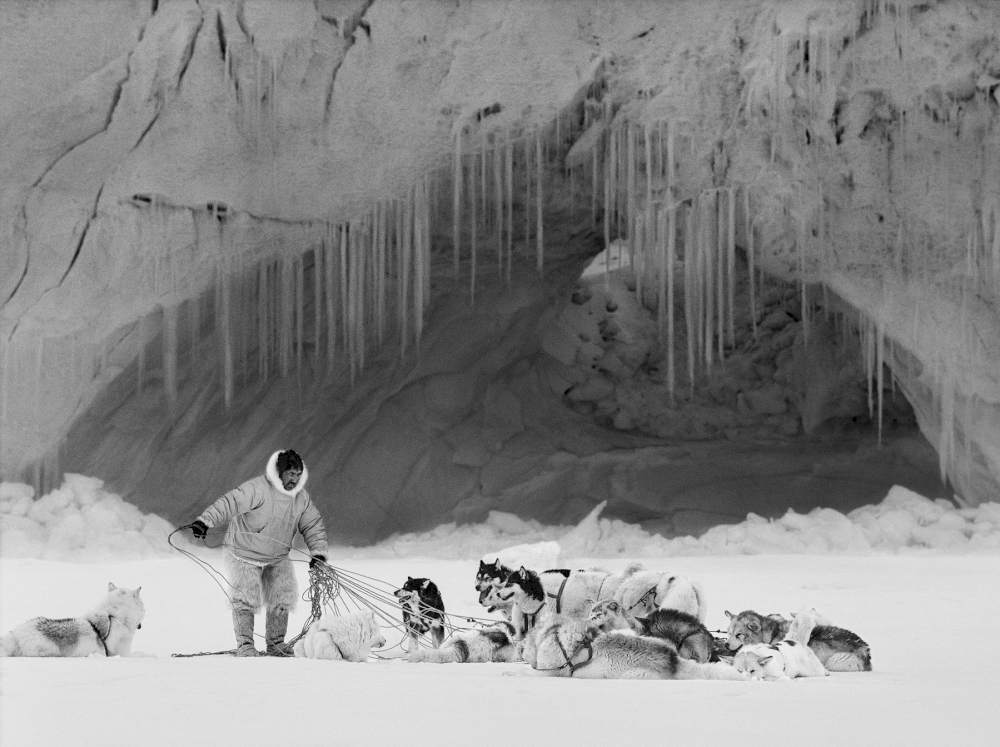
left=394, top=560, right=871, bottom=681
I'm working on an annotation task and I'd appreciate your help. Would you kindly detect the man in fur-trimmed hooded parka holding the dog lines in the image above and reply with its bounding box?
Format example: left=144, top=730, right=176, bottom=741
left=188, top=449, right=327, bottom=656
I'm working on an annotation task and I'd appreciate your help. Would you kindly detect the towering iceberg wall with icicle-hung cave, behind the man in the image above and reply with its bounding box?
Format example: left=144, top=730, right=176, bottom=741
left=0, top=0, right=1000, bottom=544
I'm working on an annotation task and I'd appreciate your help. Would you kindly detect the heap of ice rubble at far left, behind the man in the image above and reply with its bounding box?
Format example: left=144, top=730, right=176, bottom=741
left=0, top=474, right=174, bottom=561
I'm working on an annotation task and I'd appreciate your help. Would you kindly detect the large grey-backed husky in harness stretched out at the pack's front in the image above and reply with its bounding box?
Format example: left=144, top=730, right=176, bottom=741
left=524, top=615, right=746, bottom=680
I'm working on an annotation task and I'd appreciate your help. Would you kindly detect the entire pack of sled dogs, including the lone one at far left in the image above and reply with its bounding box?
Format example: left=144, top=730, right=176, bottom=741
left=0, top=560, right=872, bottom=681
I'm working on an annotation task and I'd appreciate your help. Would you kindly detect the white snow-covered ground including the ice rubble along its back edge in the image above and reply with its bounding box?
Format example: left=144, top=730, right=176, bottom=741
left=0, top=478, right=1000, bottom=747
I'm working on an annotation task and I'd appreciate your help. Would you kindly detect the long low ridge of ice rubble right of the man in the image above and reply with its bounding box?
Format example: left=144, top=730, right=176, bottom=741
left=337, top=485, right=1000, bottom=567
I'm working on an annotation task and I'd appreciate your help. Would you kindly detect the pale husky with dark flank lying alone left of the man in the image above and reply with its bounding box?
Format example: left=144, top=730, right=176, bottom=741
left=0, top=583, right=146, bottom=656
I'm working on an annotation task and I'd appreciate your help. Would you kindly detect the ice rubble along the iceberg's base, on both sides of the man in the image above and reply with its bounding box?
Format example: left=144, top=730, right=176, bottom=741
left=0, top=474, right=1000, bottom=569
